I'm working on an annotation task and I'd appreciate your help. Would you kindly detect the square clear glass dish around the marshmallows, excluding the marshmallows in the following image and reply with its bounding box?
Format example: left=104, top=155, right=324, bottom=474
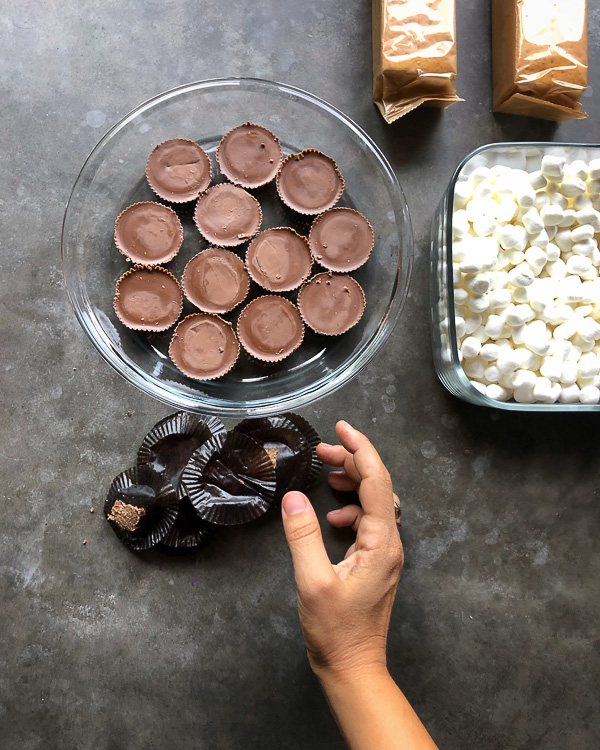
left=431, top=142, right=600, bottom=412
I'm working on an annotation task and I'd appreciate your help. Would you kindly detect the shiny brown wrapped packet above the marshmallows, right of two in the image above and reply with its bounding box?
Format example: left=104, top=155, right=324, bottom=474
left=492, top=0, right=588, bottom=122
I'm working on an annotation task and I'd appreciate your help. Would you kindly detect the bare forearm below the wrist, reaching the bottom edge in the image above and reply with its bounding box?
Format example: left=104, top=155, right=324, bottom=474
left=318, top=668, right=437, bottom=750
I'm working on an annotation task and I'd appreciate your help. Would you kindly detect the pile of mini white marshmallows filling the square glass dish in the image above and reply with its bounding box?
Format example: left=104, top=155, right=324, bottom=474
left=450, top=156, right=600, bottom=404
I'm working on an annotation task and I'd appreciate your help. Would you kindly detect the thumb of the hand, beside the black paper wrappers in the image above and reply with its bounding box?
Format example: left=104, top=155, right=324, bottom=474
left=281, top=492, right=335, bottom=591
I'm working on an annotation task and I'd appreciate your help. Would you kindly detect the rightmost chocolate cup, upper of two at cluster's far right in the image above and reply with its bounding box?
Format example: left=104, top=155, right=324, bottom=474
left=308, top=208, right=375, bottom=272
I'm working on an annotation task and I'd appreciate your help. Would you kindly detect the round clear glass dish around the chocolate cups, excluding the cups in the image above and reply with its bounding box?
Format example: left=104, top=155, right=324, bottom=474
left=62, top=78, right=413, bottom=417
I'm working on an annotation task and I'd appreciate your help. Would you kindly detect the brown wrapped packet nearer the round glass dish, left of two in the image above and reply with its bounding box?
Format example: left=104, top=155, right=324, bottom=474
left=373, top=0, right=463, bottom=122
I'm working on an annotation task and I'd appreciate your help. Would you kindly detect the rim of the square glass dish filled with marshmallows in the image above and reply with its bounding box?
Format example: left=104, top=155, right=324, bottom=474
left=446, top=141, right=600, bottom=412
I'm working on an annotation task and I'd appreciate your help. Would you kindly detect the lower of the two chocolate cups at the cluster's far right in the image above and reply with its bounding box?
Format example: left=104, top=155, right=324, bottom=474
left=298, top=271, right=366, bottom=336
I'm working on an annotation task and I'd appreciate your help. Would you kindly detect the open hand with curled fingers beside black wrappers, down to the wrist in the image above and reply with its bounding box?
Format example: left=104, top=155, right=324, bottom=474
left=282, top=422, right=404, bottom=678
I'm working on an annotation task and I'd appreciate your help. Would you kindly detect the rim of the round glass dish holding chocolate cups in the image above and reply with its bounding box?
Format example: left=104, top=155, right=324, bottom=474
left=60, top=77, right=414, bottom=417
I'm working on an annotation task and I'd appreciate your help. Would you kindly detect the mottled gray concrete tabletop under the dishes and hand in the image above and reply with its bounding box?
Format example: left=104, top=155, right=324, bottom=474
left=0, top=0, right=600, bottom=750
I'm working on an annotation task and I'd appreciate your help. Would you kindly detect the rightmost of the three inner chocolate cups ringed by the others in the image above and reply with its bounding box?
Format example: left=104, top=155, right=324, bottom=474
left=246, top=227, right=312, bottom=292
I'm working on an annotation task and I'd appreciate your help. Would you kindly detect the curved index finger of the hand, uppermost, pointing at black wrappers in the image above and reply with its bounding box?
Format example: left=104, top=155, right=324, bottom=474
left=336, top=421, right=396, bottom=525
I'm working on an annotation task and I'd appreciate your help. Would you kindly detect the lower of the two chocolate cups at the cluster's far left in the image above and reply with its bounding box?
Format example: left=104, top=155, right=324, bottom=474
left=113, top=265, right=183, bottom=331
